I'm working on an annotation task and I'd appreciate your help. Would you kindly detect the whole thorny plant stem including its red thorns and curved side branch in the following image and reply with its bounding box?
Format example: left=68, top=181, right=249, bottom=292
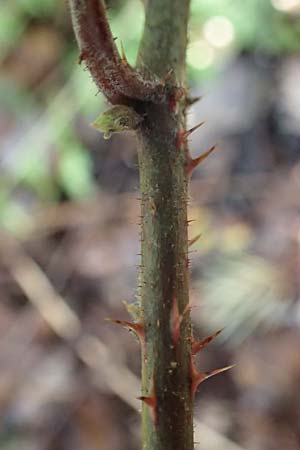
left=69, top=0, right=232, bottom=450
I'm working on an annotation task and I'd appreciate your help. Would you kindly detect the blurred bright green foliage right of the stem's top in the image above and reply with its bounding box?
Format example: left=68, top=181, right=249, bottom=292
left=188, top=0, right=300, bottom=79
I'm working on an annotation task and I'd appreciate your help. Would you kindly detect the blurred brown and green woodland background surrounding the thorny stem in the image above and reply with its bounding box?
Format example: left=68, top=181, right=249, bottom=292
left=0, top=0, right=300, bottom=450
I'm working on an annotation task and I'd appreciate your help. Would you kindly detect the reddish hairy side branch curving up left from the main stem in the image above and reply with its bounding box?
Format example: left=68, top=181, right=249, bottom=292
left=69, top=0, right=166, bottom=104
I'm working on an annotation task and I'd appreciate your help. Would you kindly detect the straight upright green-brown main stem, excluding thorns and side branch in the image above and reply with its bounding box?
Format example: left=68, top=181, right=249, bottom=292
left=138, top=0, right=193, bottom=450
